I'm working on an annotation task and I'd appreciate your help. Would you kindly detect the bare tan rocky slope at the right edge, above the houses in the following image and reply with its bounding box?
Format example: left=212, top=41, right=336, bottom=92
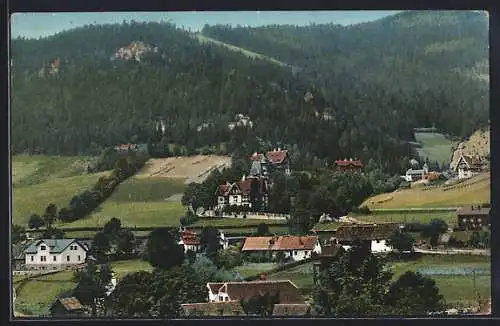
left=450, top=127, right=490, bottom=169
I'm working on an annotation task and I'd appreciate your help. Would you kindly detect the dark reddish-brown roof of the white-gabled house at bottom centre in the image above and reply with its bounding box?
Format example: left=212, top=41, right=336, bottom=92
left=220, top=280, right=305, bottom=304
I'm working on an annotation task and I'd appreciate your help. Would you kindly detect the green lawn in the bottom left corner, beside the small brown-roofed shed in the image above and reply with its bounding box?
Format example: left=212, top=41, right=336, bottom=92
left=16, top=272, right=76, bottom=316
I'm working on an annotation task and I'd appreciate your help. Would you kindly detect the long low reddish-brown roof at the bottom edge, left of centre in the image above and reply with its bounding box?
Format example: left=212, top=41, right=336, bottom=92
left=181, top=300, right=246, bottom=317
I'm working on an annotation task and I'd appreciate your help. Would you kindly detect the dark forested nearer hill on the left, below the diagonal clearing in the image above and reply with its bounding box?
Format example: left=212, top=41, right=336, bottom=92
left=12, top=23, right=426, bottom=173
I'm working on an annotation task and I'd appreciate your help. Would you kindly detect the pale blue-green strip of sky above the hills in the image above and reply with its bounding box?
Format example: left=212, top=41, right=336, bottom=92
left=11, top=11, right=400, bottom=38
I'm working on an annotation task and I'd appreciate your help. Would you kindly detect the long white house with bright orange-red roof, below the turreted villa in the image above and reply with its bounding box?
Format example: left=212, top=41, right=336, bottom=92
left=241, top=236, right=321, bottom=261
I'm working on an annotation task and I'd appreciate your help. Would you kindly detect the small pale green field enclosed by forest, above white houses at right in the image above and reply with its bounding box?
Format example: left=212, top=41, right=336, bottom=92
left=415, top=132, right=457, bottom=164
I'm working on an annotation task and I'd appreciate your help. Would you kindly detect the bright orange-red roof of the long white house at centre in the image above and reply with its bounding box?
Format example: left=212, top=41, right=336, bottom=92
left=241, top=236, right=318, bottom=251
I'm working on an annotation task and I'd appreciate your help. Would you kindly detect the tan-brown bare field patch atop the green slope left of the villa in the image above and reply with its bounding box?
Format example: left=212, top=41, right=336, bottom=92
left=136, top=155, right=231, bottom=183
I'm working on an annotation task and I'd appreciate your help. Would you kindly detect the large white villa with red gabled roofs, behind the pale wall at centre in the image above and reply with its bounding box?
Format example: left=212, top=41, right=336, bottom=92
left=215, top=176, right=268, bottom=210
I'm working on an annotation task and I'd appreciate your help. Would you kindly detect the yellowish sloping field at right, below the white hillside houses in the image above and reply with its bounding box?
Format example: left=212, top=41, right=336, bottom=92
left=362, top=173, right=491, bottom=209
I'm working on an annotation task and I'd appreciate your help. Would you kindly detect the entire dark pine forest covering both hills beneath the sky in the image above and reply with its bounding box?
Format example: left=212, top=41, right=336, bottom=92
left=11, top=12, right=489, bottom=173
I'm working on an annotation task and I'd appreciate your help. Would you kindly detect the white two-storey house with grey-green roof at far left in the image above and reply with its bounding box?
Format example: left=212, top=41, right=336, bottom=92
left=24, top=239, right=88, bottom=270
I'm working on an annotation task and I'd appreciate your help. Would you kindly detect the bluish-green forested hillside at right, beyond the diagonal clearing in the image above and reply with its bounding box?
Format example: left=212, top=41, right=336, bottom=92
left=202, top=11, right=489, bottom=137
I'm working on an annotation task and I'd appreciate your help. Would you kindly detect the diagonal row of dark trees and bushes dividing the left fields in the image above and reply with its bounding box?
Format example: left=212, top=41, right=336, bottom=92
left=28, top=152, right=148, bottom=229
